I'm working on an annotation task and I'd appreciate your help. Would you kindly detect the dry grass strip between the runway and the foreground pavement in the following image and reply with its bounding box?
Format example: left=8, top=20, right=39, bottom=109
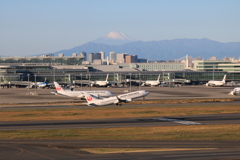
left=0, top=124, right=240, bottom=141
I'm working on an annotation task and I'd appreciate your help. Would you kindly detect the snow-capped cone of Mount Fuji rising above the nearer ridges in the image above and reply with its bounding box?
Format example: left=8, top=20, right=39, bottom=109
left=92, top=31, right=136, bottom=45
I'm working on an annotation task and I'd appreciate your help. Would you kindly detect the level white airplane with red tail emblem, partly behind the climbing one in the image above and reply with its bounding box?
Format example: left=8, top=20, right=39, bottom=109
left=51, top=82, right=113, bottom=99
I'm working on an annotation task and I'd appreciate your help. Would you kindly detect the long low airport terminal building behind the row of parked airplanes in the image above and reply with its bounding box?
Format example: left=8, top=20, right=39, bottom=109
left=0, top=56, right=240, bottom=86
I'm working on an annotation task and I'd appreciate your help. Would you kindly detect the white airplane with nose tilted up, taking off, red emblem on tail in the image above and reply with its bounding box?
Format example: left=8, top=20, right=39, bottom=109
left=84, top=90, right=149, bottom=106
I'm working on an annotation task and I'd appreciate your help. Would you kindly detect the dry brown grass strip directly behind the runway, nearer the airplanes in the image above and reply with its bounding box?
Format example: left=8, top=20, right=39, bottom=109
left=0, top=104, right=240, bottom=121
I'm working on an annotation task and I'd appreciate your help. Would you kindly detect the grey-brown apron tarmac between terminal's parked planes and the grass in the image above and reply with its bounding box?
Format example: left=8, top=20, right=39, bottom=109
left=0, top=85, right=240, bottom=105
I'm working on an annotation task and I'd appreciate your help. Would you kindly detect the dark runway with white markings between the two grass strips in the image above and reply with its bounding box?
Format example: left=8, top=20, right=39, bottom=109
left=0, top=113, right=240, bottom=130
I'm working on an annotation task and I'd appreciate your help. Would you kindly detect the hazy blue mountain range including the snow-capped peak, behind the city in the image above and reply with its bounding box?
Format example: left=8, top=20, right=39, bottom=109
left=47, top=32, right=240, bottom=60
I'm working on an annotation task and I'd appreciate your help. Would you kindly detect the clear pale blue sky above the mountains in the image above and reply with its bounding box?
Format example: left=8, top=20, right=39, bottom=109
left=0, top=0, right=240, bottom=57
